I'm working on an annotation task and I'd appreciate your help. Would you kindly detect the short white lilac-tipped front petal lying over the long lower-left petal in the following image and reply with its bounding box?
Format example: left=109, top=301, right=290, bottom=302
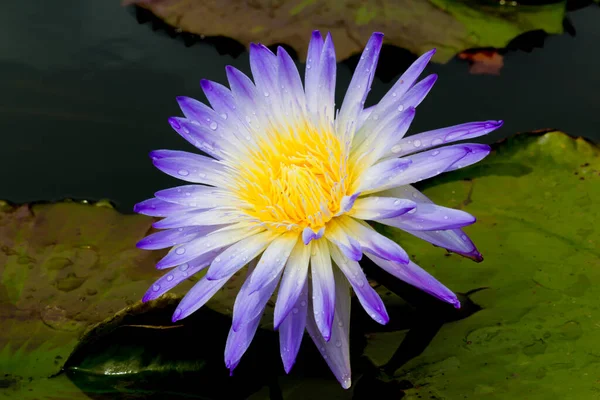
left=206, top=231, right=274, bottom=280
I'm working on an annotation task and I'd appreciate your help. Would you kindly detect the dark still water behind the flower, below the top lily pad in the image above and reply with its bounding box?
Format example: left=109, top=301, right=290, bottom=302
left=0, top=0, right=600, bottom=216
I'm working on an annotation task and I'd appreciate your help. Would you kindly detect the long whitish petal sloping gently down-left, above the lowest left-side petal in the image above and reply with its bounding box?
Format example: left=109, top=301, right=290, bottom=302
left=156, top=227, right=261, bottom=269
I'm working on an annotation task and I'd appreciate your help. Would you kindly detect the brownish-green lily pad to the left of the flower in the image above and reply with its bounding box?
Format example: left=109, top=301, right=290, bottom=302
left=0, top=202, right=248, bottom=399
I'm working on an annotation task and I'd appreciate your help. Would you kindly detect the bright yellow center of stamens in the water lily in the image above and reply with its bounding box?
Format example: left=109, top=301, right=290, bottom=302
left=236, top=123, right=348, bottom=231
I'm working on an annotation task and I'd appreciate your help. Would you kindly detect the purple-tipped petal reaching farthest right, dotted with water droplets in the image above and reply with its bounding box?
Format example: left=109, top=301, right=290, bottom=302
left=384, top=121, right=503, bottom=157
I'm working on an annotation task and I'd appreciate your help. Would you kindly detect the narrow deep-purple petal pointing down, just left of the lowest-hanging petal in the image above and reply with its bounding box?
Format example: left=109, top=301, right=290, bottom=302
left=277, top=280, right=308, bottom=374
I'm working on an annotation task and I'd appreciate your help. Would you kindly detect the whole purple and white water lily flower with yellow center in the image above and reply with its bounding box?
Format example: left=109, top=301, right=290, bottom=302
left=135, top=31, right=502, bottom=388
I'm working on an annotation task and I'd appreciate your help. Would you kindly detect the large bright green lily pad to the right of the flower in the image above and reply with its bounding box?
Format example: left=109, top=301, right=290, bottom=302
left=365, top=132, right=600, bottom=400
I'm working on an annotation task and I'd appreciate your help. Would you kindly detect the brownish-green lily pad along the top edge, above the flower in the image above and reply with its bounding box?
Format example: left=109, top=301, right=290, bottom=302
left=123, top=0, right=566, bottom=62
